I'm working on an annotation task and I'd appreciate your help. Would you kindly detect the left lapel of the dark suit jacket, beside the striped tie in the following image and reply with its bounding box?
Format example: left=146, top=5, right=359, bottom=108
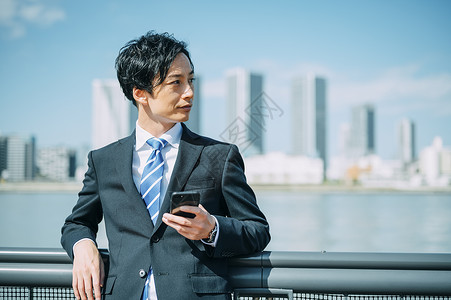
left=115, top=132, right=154, bottom=232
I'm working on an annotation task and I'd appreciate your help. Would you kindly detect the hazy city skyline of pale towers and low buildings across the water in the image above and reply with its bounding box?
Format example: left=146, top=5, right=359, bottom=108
left=0, top=74, right=451, bottom=187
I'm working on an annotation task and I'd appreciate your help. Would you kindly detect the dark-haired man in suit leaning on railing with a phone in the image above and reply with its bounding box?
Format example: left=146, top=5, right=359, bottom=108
left=61, top=32, right=270, bottom=300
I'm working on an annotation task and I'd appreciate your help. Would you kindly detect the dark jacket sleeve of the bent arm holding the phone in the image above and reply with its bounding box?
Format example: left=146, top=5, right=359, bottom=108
left=207, top=145, right=270, bottom=257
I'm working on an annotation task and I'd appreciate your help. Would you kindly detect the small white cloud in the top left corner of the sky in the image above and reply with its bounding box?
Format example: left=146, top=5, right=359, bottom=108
left=0, top=0, right=66, bottom=38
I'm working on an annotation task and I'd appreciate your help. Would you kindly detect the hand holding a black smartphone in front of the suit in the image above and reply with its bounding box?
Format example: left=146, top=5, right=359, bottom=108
left=162, top=192, right=216, bottom=240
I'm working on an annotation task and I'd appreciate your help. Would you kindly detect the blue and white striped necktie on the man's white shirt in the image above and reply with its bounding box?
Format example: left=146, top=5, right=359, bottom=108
left=140, top=138, right=167, bottom=224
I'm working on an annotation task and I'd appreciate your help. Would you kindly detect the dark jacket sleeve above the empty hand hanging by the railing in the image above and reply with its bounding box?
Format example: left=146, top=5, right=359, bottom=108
left=61, top=152, right=102, bottom=260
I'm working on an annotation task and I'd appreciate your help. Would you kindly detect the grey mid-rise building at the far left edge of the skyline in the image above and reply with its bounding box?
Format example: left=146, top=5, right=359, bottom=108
left=0, top=135, right=36, bottom=181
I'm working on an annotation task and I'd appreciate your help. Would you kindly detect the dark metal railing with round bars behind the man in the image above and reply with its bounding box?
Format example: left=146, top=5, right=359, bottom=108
left=0, top=248, right=451, bottom=299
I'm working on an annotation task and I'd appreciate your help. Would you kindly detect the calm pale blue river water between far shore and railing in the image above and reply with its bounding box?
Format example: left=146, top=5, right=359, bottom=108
left=0, top=190, right=451, bottom=253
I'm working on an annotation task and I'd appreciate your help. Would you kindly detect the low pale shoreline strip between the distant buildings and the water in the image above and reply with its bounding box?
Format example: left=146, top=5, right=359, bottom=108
left=0, top=181, right=451, bottom=194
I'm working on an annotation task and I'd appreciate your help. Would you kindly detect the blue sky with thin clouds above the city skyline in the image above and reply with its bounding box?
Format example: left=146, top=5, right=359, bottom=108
left=0, top=0, right=451, bottom=158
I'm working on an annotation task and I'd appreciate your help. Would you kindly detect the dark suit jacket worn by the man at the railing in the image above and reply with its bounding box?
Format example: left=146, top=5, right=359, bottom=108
left=61, top=125, right=270, bottom=300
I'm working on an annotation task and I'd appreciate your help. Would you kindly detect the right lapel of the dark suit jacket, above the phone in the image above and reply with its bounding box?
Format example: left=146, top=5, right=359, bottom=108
left=154, top=123, right=204, bottom=232
